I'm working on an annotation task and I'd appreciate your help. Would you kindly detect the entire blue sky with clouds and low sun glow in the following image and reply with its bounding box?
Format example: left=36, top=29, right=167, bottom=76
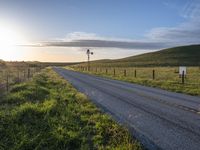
left=0, top=0, right=200, bottom=62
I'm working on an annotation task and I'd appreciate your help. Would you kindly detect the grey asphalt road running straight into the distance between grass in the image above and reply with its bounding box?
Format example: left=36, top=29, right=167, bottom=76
left=54, top=68, right=200, bottom=150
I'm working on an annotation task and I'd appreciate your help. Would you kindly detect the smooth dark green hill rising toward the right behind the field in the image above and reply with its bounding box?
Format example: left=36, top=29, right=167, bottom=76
left=91, top=45, right=200, bottom=67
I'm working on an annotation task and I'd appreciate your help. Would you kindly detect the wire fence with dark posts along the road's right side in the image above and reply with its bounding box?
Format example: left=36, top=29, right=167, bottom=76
left=73, top=66, right=200, bottom=87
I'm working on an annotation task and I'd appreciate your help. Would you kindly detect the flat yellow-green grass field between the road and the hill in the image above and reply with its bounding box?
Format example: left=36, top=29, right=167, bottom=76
left=70, top=66, right=200, bottom=96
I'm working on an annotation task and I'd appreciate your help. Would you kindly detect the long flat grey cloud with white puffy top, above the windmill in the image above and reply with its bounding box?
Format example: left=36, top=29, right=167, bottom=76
left=23, top=32, right=167, bottom=50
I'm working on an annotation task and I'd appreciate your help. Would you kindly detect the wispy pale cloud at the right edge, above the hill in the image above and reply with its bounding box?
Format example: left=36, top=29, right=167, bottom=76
left=146, top=0, right=200, bottom=46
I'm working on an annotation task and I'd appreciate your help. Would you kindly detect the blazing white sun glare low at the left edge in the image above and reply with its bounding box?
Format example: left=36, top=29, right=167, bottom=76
left=0, top=23, right=26, bottom=60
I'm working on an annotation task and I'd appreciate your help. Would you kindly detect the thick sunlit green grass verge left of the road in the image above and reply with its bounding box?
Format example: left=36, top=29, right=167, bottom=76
left=0, top=68, right=142, bottom=150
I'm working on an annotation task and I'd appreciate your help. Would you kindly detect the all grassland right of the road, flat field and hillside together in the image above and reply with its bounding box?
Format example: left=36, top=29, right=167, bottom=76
left=71, top=45, right=200, bottom=96
